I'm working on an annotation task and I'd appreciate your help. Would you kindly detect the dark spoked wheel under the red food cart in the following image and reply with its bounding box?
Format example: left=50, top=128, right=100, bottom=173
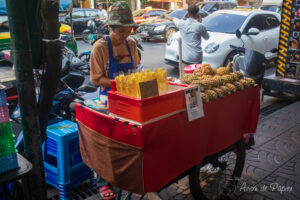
left=189, top=138, right=245, bottom=200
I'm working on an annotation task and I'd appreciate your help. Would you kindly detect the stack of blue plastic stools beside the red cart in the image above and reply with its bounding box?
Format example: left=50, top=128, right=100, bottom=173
left=43, top=120, right=93, bottom=200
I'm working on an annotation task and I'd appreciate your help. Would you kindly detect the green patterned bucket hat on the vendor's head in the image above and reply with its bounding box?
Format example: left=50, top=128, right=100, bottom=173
left=107, top=1, right=138, bottom=27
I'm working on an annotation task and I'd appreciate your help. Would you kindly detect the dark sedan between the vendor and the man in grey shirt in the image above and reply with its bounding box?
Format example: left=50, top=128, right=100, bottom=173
left=137, top=9, right=208, bottom=41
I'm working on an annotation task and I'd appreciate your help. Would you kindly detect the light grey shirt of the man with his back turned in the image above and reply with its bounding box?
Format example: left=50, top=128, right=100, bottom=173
left=173, top=18, right=209, bottom=63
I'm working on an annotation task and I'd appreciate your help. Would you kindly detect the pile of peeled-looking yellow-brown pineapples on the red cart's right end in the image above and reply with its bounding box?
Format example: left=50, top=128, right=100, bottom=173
left=181, top=62, right=255, bottom=103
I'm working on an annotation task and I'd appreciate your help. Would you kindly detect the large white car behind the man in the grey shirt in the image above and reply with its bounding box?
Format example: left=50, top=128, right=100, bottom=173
left=165, top=9, right=280, bottom=68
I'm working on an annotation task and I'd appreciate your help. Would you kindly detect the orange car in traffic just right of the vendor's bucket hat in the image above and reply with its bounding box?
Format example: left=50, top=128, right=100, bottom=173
left=134, top=8, right=166, bottom=24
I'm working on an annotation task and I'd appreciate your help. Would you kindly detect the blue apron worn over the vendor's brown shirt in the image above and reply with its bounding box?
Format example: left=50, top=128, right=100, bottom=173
left=100, top=36, right=134, bottom=99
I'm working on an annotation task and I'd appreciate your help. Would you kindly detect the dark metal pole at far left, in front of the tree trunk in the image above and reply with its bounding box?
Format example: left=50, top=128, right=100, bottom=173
left=6, top=0, right=47, bottom=200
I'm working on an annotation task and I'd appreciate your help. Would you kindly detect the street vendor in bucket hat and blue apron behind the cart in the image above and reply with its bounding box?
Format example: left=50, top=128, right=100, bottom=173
left=90, top=1, right=140, bottom=199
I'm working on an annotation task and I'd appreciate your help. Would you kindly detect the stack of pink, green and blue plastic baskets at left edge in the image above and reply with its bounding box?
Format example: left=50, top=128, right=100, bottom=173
left=0, top=88, right=18, bottom=174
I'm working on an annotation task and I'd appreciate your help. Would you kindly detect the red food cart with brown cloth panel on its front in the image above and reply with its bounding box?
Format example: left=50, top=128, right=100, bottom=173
left=76, top=83, right=260, bottom=199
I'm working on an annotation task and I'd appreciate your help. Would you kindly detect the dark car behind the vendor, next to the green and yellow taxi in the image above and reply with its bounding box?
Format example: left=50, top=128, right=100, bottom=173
left=59, top=8, right=98, bottom=36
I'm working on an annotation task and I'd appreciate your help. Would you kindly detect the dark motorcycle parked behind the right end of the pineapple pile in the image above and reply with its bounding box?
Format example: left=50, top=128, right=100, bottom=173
left=230, top=29, right=277, bottom=85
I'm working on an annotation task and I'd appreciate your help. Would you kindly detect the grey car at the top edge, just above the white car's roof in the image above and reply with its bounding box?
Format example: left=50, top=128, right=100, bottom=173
left=196, top=1, right=237, bottom=13
